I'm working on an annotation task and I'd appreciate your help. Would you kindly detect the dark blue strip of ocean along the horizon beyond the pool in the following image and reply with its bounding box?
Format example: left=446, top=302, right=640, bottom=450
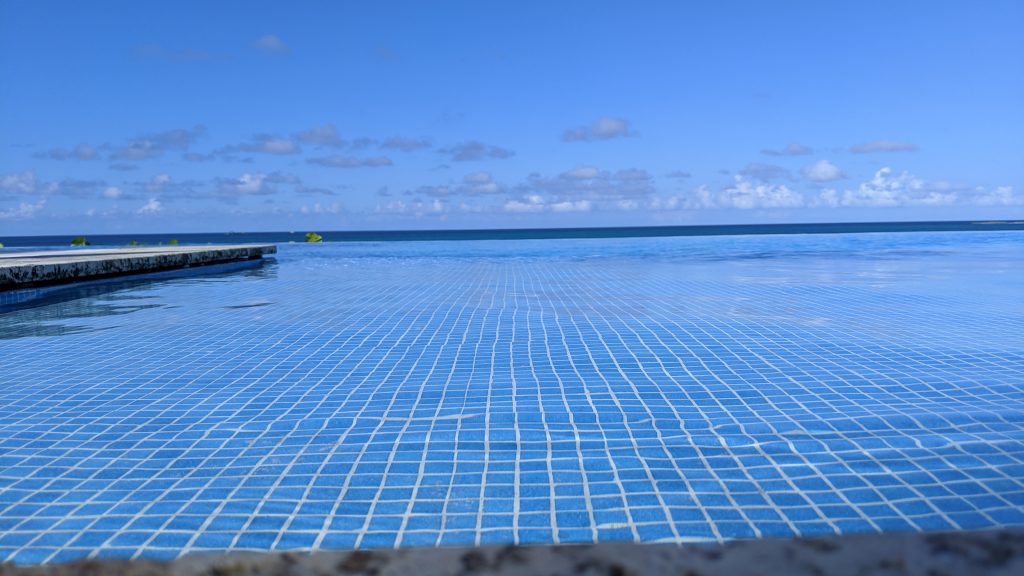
left=0, top=220, right=1024, bottom=247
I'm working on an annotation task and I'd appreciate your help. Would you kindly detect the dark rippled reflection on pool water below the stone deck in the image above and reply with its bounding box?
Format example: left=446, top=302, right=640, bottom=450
left=0, top=258, right=278, bottom=340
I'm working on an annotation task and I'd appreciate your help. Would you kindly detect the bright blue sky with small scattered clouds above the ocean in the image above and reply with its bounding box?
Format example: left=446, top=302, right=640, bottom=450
left=0, top=0, right=1024, bottom=236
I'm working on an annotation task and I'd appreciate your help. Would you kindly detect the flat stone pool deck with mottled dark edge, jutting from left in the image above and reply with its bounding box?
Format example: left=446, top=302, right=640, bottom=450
left=0, top=244, right=278, bottom=291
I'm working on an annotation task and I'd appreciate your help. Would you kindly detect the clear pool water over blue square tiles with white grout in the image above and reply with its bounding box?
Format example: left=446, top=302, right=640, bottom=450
left=0, top=232, right=1024, bottom=563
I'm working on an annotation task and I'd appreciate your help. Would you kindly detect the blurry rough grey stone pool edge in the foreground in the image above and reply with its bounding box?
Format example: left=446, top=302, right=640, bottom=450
left=0, top=530, right=1024, bottom=576
